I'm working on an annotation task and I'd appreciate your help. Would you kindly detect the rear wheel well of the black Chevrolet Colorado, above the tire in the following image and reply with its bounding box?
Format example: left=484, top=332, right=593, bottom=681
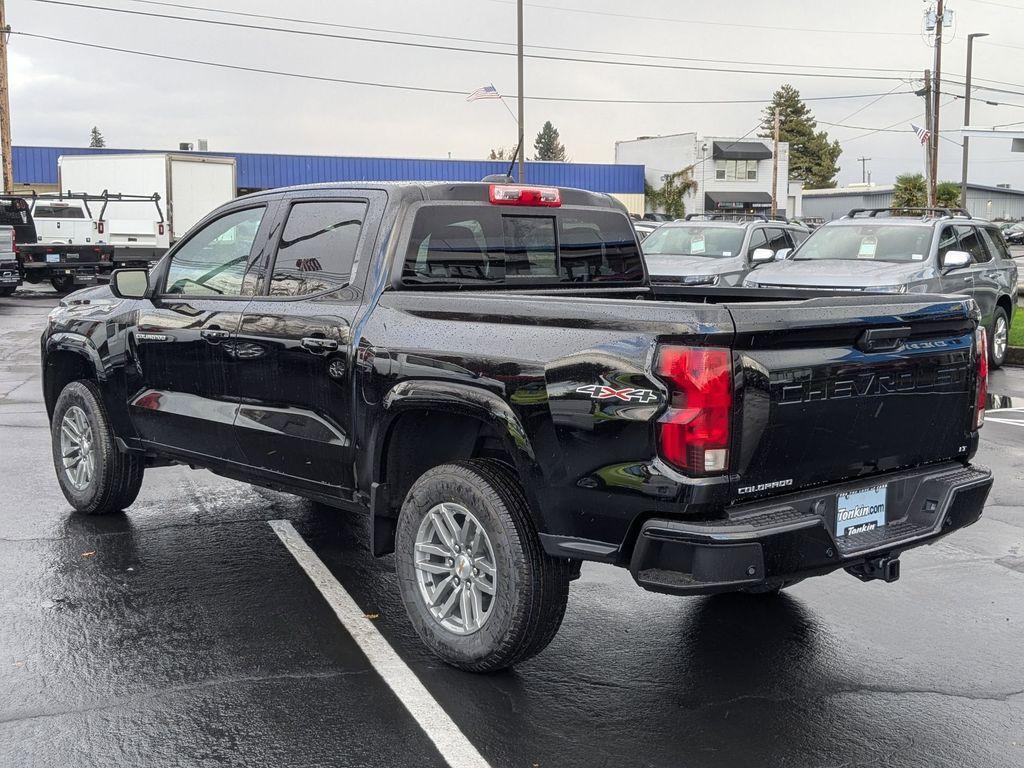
left=373, top=410, right=514, bottom=555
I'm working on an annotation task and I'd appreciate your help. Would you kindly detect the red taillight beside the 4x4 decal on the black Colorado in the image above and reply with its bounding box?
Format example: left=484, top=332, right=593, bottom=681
left=655, top=346, right=732, bottom=475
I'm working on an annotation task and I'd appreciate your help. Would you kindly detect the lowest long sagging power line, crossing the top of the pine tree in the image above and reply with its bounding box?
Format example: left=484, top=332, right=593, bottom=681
left=10, top=31, right=910, bottom=105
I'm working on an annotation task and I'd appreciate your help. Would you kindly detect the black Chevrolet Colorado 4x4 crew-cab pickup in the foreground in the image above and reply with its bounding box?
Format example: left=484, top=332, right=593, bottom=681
left=42, top=183, right=992, bottom=671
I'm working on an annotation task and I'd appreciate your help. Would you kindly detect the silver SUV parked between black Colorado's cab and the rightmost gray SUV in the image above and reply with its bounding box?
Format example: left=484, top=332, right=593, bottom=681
left=641, top=213, right=809, bottom=286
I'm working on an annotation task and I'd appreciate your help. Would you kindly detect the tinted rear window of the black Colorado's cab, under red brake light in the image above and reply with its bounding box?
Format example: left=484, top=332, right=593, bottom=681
left=402, top=205, right=644, bottom=285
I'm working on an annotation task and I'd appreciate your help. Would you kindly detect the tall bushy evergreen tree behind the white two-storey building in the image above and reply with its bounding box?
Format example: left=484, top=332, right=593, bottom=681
left=759, top=84, right=843, bottom=189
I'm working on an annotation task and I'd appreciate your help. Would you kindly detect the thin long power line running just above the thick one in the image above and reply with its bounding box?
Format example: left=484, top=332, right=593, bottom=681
left=116, top=0, right=925, bottom=77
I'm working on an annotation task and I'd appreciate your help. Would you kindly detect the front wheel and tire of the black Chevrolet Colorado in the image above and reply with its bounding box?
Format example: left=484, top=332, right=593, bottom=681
left=50, top=381, right=145, bottom=515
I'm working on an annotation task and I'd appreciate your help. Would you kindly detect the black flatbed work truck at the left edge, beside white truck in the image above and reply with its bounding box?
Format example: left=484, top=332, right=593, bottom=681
left=0, top=195, right=114, bottom=293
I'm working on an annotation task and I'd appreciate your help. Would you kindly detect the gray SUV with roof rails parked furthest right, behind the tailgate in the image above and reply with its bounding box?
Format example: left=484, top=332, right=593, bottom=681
left=743, top=208, right=1017, bottom=368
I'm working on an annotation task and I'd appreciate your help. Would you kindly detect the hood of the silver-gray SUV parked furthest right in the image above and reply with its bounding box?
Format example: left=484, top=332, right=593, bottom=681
left=749, top=259, right=929, bottom=288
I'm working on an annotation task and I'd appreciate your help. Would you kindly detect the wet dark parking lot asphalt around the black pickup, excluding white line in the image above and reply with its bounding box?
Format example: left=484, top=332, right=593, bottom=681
left=0, top=290, right=1024, bottom=768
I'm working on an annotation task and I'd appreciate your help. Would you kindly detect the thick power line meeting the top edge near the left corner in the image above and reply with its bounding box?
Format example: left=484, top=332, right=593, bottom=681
left=19, top=0, right=906, bottom=82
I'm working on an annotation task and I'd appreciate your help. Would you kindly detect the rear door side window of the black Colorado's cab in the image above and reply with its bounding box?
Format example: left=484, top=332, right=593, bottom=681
left=270, top=201, right=367, bottom=296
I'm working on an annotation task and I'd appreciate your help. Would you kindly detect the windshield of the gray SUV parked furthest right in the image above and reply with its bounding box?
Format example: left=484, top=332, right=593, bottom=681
left=793, top=224, right=932, bottom=263
